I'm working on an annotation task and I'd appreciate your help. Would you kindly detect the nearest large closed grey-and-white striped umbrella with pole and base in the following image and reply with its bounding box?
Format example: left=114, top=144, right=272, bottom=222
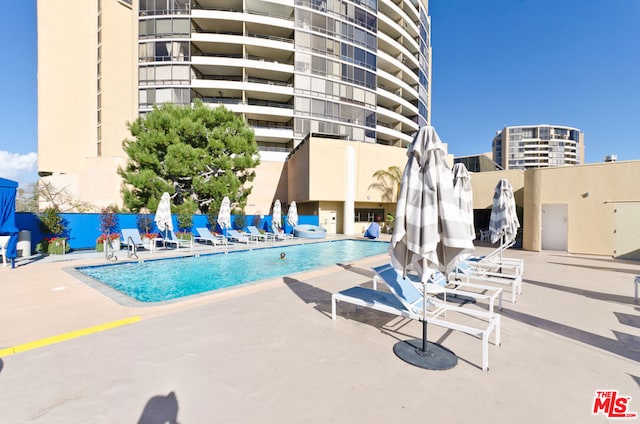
left=389, top=126, right=473, bottom=369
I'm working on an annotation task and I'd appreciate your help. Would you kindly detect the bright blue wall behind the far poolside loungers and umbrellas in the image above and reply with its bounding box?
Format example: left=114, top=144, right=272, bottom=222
left=16, top=212, right=319, bottom=252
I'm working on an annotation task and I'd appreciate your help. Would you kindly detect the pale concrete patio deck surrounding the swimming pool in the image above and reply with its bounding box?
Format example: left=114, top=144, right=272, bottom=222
left=0, top=237, right=640, bottom=424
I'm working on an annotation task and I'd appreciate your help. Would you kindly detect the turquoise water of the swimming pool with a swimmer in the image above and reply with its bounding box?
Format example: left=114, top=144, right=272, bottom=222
left=77, top=240, right=389, bottom=302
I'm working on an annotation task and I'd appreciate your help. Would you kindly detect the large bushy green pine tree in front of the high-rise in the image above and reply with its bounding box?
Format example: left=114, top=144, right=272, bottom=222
left=118, top=101, right=260, bottom=213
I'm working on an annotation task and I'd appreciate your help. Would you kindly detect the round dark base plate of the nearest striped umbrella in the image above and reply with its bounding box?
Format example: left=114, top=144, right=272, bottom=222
left=393, top=339, right=458, bottom=370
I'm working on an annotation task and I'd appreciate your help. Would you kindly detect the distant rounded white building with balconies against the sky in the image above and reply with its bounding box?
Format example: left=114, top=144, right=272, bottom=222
left=493, top=125, right=584, bottom=169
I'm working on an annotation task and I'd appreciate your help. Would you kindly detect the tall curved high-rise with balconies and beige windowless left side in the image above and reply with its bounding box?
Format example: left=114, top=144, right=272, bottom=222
left=37, top=0, right=431, bottom=210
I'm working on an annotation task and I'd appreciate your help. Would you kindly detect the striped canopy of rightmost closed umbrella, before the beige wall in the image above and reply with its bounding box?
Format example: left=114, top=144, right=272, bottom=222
left=489, top=178, right=520, bottom=244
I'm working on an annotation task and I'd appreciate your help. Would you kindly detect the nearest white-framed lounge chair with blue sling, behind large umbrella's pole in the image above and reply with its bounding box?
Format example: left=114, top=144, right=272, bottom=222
left=331, top=265, right=500, bottom=371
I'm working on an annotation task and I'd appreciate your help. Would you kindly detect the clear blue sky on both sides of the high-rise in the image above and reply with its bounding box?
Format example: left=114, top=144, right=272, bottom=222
left=0, top=0, right=640, bottom=182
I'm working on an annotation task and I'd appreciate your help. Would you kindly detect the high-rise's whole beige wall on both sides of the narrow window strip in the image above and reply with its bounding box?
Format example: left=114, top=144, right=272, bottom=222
left=37, top=0, right=137, bottom=210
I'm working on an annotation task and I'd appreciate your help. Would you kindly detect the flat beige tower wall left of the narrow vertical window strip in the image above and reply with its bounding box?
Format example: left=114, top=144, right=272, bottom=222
left=37, top=0, right=98, bottom=174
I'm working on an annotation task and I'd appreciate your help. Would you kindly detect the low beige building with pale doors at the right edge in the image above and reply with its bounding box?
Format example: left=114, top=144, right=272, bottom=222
left=464, top=161, right=640, bottom=259
